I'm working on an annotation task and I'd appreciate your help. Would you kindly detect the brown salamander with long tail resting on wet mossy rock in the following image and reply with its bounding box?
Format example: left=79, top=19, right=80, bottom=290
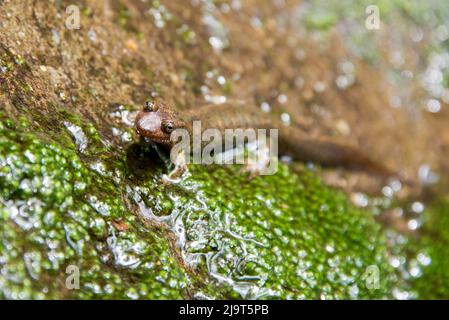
left=135, top=101, right=397, bottom=178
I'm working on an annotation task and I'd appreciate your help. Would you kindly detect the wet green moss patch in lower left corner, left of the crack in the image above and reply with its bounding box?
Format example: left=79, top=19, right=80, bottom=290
left=0, top=115, right=187, bottom=299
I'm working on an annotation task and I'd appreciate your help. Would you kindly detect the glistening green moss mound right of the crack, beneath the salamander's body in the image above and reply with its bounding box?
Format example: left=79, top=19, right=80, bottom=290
left=180, top=165, right=394, bottom=299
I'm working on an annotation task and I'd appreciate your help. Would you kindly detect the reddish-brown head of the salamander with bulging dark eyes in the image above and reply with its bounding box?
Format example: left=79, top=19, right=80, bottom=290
left=134, top=101, right=184, bottom=146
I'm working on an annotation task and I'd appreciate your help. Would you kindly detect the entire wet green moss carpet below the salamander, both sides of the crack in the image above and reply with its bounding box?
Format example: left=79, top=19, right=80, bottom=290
left=0, top=113, right=400, bottom=298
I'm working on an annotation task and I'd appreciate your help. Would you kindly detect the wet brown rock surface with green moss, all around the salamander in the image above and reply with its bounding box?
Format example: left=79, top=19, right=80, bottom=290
left=0, top=0, right=449, bottom=299
